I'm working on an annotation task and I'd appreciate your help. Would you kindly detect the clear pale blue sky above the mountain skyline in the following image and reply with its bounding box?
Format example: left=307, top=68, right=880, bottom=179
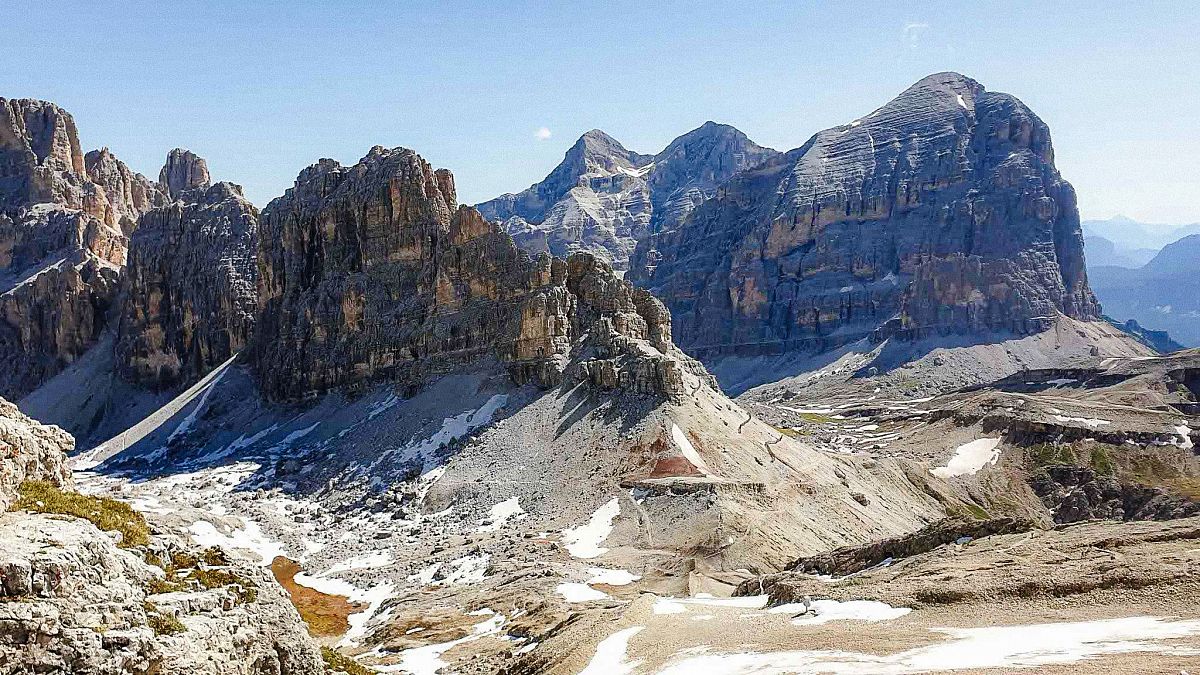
left=9, top=0, right=1200, bottom=223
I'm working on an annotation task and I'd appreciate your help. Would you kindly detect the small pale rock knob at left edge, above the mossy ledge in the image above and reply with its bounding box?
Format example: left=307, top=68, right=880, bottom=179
left=0, top=391, right=74, bottom=513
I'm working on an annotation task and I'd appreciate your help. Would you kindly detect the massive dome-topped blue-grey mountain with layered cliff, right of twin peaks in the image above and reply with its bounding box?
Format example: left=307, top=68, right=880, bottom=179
left=630, top=73, right=1098, bottom=356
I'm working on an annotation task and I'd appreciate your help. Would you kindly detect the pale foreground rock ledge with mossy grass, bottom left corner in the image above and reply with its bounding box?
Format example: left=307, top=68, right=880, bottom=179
left=0, top=399, right=325, bottom=675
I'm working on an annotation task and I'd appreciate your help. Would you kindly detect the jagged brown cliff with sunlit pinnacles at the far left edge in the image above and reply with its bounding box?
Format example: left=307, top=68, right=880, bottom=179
left=0, top=98, right=164, bottom=398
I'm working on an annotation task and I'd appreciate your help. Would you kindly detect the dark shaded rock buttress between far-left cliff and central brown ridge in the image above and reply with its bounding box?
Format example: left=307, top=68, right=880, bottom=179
left=115, top=180, right=258, bottom=388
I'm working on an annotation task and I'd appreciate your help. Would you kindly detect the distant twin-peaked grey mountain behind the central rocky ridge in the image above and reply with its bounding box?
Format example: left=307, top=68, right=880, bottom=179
left=476, top=123, right=775, bottom=269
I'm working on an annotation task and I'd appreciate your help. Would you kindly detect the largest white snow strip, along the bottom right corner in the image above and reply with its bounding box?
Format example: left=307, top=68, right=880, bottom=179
left=659, top=616, right=1200, bottom=675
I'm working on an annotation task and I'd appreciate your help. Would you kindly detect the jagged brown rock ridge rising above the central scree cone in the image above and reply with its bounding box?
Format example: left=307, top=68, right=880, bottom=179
left=253, top=148, right=702, bottom=399
